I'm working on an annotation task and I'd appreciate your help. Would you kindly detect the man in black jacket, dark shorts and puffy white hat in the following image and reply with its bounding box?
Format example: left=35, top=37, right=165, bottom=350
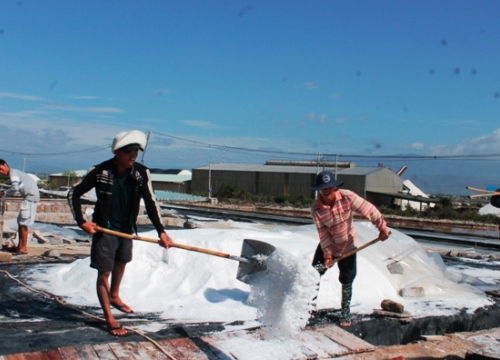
left=68, top=130, right=172, bottom=336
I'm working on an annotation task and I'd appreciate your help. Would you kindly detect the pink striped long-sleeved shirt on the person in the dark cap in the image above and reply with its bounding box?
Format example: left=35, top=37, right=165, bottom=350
left=311, top=190, right=387, bottom=259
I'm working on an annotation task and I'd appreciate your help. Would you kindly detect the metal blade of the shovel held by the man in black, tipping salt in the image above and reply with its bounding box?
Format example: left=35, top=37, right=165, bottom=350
left=236, top=239, right=276, bottom=282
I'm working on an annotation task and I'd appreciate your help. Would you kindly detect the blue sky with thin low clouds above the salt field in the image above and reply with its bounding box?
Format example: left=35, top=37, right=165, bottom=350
left=0, top=0, right=500, bottom=193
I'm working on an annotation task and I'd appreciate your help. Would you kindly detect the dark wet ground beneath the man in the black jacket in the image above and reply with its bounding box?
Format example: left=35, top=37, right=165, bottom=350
left=0, top=264, right=229, bottom=355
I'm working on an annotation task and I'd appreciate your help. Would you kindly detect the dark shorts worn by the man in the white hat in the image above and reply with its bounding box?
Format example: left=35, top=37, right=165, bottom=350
left=90, top=233, right=133, bottom=271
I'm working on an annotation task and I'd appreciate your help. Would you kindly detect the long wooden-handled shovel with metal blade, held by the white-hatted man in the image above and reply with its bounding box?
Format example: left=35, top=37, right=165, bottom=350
left=95, top=226, right=276, bottom=281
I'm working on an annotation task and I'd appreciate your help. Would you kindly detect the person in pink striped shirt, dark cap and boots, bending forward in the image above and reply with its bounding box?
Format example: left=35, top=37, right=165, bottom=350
left=311, top=171, right=390, bottom=326
